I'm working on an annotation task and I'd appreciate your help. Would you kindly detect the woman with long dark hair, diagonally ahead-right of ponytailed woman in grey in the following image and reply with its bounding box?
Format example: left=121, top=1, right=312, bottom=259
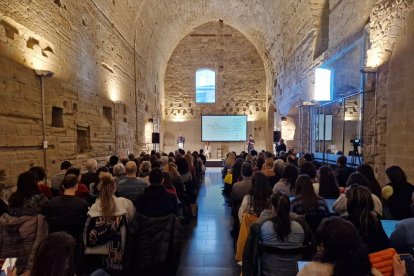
left=291, top=174, right=329, bottom=216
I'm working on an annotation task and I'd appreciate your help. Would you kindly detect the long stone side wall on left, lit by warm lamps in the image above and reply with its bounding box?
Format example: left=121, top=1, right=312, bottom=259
left=0, top=0, right=159, bottom=188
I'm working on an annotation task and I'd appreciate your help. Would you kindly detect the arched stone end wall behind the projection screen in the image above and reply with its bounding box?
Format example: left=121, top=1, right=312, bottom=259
left=162, top=21, right=267, bottom=154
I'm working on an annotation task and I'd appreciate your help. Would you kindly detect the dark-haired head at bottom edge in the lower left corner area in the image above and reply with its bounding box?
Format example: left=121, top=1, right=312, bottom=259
left=30, top=232, right=75, bottom=276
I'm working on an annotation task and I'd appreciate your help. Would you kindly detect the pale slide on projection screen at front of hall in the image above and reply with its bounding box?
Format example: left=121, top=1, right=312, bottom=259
left=201, top=115, right=247, bottom=142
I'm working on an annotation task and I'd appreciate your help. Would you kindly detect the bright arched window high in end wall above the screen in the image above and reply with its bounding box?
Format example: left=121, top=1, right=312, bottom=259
left=196, top=69, right=216, bottom=103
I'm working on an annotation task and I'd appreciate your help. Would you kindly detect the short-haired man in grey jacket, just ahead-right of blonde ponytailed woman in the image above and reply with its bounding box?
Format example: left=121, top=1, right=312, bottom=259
left=114, top=161, right=147, bottom=206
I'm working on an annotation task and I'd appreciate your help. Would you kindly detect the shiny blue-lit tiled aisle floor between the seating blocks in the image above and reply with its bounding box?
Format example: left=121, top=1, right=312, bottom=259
left=177, top=168, right=240, bottom=276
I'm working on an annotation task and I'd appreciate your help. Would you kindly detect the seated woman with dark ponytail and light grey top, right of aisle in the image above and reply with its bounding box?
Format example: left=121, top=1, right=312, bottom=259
left=242, top=192, right=307, bottom=276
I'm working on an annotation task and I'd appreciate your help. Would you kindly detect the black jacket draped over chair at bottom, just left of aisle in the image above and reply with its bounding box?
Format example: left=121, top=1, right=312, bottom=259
left=124, top=213, right=183, bottom=276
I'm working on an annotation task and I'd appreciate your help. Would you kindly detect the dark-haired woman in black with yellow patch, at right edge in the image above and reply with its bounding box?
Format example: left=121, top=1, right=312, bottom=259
left=382, top=166, right=414, bottom=219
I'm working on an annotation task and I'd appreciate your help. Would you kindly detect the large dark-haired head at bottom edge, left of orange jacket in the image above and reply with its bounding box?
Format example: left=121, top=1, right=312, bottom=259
left=315, top=217, right=371, bottom=276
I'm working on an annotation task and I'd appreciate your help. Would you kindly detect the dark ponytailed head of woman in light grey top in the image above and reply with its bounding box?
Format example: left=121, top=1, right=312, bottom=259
left=271, top=192, right=291, bottom=241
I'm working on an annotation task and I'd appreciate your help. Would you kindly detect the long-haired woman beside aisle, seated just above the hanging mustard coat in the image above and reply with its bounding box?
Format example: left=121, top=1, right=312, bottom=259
left=239, top=172, right=272, bottom=221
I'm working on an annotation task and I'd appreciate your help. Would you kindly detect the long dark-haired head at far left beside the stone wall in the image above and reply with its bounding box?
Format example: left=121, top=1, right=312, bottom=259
left=9, top=171, right=40, bottom=207
